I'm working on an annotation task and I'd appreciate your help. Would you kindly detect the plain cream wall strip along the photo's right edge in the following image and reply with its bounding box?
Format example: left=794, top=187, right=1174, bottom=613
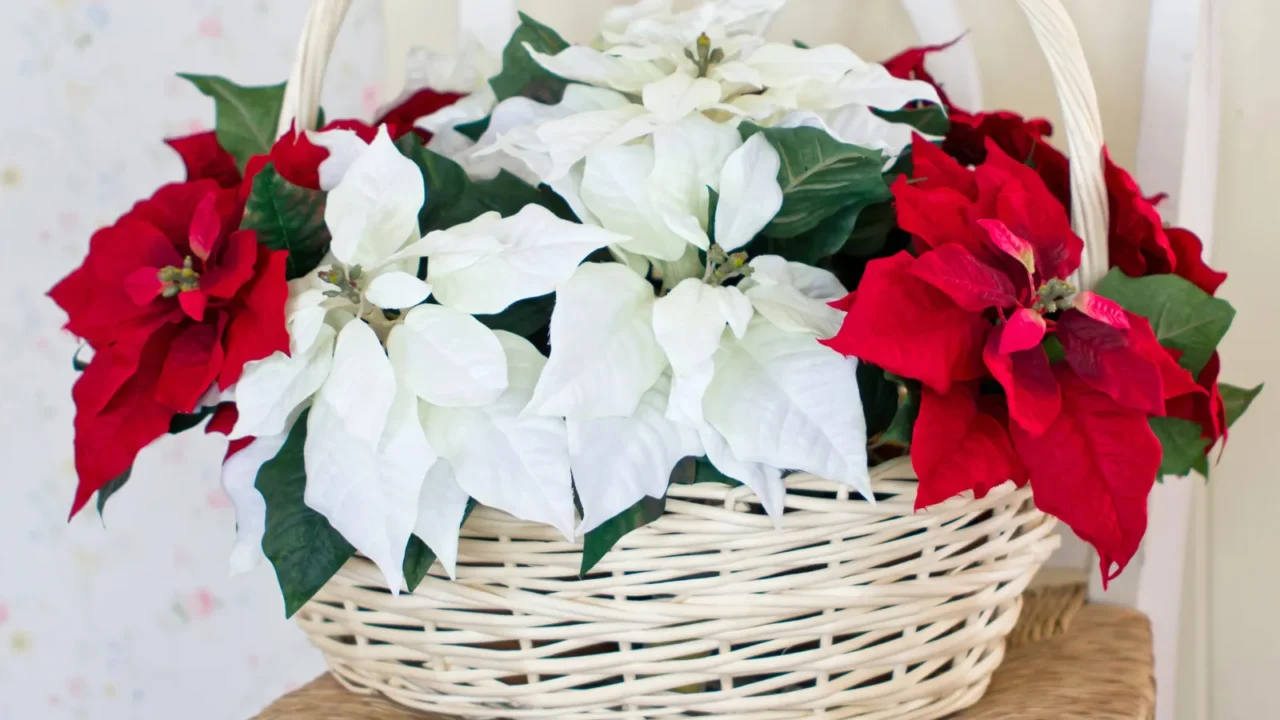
left=1207, top=0, right=1280, bottom=720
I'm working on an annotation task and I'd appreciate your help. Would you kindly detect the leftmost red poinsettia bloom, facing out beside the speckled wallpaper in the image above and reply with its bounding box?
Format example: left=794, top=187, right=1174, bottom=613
left=50, top=179, right=289, bottom=515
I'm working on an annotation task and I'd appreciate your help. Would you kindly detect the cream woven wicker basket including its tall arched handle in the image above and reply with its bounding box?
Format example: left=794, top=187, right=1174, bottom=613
left=280, top=0, right=1107, bottom=720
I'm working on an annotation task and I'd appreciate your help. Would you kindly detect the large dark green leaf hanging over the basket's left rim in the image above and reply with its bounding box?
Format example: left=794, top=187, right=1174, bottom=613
left=255, top=411, right=356, bottom=618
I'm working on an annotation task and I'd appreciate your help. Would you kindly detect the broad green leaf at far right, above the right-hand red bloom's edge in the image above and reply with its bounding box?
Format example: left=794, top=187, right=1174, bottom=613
left=1097, top=268, right=1235, bottom=375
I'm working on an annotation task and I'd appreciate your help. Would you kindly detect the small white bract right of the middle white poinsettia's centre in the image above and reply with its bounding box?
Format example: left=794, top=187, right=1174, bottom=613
left=737, top=255, right=847, bottom=338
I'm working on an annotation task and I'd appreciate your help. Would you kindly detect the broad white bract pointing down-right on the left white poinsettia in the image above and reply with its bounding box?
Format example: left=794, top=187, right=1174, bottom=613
left=422, top=332, right=573, bottom=539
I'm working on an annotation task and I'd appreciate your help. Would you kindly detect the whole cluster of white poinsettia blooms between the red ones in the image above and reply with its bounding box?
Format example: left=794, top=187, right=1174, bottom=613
left=224, top=0, right=880, bottom=588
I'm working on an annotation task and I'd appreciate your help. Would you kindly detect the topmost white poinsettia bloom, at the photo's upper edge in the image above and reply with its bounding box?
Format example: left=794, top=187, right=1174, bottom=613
left=481, top=0, right=940, bottom=215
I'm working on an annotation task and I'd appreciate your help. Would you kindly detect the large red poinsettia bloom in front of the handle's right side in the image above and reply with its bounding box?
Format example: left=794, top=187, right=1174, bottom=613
left=826, top=138, right=1194, bottom=579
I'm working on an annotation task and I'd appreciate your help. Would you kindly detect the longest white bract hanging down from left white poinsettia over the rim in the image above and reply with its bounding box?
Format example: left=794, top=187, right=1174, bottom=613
left=303, top=320, right=436, bottom=592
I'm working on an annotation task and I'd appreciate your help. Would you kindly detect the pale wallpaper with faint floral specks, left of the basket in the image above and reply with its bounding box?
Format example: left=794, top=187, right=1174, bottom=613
left=0, top=0, right=384, bottom=720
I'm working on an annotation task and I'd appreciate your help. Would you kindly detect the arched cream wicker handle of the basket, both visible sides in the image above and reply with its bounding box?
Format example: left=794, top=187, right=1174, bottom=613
left=278, top=0, right=1108, bottom=288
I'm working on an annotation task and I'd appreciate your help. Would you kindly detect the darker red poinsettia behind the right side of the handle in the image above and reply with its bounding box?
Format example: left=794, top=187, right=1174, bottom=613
left=884, top=45, right=1226, bottom=295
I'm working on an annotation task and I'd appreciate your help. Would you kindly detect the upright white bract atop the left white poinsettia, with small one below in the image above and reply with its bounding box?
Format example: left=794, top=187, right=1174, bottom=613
left=325, top=126, right=431, bottom=308
